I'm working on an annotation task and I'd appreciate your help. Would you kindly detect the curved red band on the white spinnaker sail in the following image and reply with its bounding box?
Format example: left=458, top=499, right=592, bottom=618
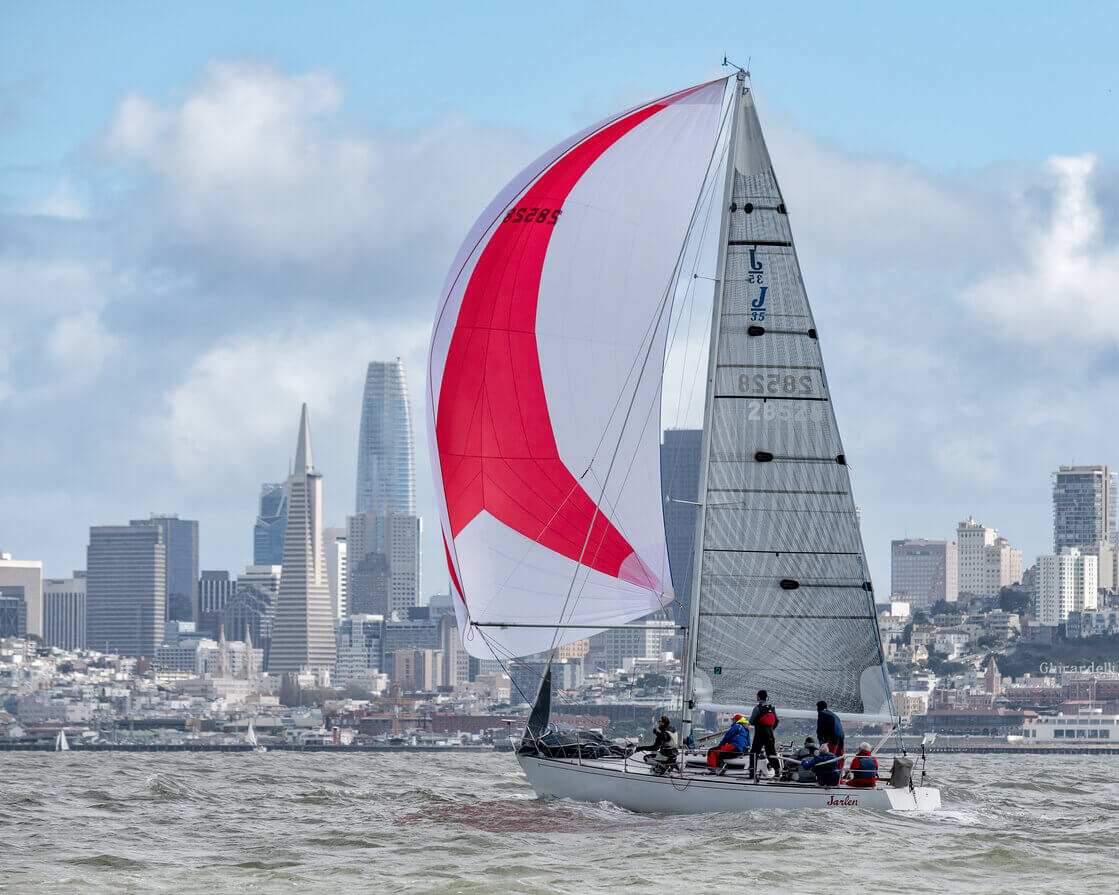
left=435, top=85, right=707, bottom=591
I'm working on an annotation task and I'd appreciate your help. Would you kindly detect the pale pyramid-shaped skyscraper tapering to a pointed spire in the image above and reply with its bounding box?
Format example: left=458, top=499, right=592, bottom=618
left=269, top=404, right=335, bottom=671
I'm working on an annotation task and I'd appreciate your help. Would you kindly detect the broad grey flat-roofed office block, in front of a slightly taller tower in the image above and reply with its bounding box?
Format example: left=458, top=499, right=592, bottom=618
left=85, top=521, right=167, bottom=658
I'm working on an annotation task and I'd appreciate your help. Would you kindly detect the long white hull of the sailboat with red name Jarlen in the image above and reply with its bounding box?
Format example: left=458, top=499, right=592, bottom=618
left=517, top=755, right=940, bottom=814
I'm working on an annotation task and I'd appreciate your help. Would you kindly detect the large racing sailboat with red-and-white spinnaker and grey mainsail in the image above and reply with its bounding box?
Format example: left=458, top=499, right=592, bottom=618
left=427, top=69, right=940, bottom=813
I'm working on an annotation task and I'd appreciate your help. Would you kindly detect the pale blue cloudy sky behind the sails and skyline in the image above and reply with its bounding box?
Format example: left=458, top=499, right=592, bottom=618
left=0, top=3, right=1119, bottom=592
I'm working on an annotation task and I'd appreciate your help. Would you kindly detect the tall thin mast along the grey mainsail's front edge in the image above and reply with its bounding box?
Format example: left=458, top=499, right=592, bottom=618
left=680, top=68, right=746, bottom=743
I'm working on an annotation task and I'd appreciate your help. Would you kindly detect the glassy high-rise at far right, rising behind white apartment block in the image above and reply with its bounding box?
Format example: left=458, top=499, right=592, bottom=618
left=1053, top=467, right=1116, bottom=554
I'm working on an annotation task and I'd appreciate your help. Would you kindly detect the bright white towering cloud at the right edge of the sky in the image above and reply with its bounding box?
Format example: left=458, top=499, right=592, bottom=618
left=961, top=153, right=1119, bottom=343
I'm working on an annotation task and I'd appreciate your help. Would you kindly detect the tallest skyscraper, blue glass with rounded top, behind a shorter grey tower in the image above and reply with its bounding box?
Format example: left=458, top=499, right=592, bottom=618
left=355, top=358, right=416, bottom=516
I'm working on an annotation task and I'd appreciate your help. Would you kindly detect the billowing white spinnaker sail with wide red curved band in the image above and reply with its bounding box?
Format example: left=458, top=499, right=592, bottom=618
left=427, top=81, right=726, bottom=658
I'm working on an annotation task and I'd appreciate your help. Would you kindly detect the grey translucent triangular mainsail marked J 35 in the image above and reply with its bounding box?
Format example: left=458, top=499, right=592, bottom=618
left=693, top=91, right=890, bottom=715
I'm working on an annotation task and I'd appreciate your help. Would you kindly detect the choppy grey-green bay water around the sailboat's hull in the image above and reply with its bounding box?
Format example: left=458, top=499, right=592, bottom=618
left=0, top=752, right=1119, bottom=895
